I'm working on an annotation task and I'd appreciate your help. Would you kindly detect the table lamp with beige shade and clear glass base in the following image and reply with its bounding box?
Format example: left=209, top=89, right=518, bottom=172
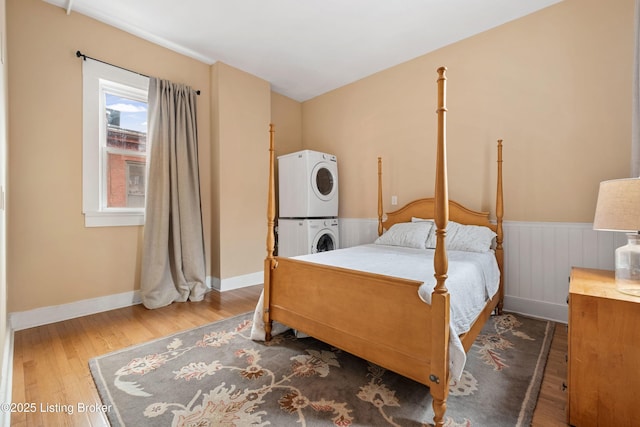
left=593, top=178, right=640, bottom=297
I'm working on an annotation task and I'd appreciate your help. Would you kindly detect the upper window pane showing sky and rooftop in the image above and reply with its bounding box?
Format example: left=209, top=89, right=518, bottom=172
left=105, top=92, right=147, bottom=152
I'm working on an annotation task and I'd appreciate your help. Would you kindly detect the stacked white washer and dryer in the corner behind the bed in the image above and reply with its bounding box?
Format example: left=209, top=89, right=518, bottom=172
left=278, top=150, right=340, bottom=257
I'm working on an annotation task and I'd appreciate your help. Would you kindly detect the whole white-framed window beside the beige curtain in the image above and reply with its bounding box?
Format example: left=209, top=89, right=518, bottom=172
left=82, top=59, right=149, bottom=227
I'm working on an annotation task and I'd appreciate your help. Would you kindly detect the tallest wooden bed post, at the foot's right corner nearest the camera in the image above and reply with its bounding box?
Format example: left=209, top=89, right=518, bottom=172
left=429, top=67, right=450, bottom=427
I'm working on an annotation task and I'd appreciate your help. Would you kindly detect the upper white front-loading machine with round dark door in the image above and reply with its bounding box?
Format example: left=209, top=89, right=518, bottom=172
left=278, top=150, right=338, bottom=218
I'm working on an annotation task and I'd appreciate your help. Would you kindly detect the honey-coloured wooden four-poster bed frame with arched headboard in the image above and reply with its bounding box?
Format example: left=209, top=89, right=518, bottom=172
left=263, top=67, right=504, bottom=426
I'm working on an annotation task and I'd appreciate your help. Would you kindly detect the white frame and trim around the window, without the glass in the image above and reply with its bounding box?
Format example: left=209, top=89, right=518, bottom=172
left=82, top=59, right=150, bottom=227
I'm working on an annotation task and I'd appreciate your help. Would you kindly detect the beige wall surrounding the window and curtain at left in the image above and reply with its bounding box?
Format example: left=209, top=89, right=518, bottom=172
left=7, top=0, right=212, bottom=311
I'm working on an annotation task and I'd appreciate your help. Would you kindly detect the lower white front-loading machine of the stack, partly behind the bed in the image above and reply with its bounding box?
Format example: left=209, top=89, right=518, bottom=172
left=278, top=218, right=340, bottom=257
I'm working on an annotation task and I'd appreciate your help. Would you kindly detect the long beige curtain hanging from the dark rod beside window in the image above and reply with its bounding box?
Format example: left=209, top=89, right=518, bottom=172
left=140, top=77, right=206, bottom=308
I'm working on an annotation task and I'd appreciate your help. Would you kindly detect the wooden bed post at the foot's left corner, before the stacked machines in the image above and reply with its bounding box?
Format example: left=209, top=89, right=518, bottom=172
left=262, top=124, right=277, bottom=341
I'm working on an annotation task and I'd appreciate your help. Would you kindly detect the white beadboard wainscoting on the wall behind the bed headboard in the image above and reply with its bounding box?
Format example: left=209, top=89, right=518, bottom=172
left=340, top=218, right=626, bottom=323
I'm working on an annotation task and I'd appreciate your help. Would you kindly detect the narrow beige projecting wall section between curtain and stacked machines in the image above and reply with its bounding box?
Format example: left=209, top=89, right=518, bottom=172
left=212, top=62, right=271, bottom=280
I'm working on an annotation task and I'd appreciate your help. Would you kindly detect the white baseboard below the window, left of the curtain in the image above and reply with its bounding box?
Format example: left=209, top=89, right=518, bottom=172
left=9, top=291, right=142, bottom=331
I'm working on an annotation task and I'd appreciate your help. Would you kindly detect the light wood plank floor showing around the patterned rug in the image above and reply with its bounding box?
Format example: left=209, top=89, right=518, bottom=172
left=11, top=286, right=567, bottom=427
